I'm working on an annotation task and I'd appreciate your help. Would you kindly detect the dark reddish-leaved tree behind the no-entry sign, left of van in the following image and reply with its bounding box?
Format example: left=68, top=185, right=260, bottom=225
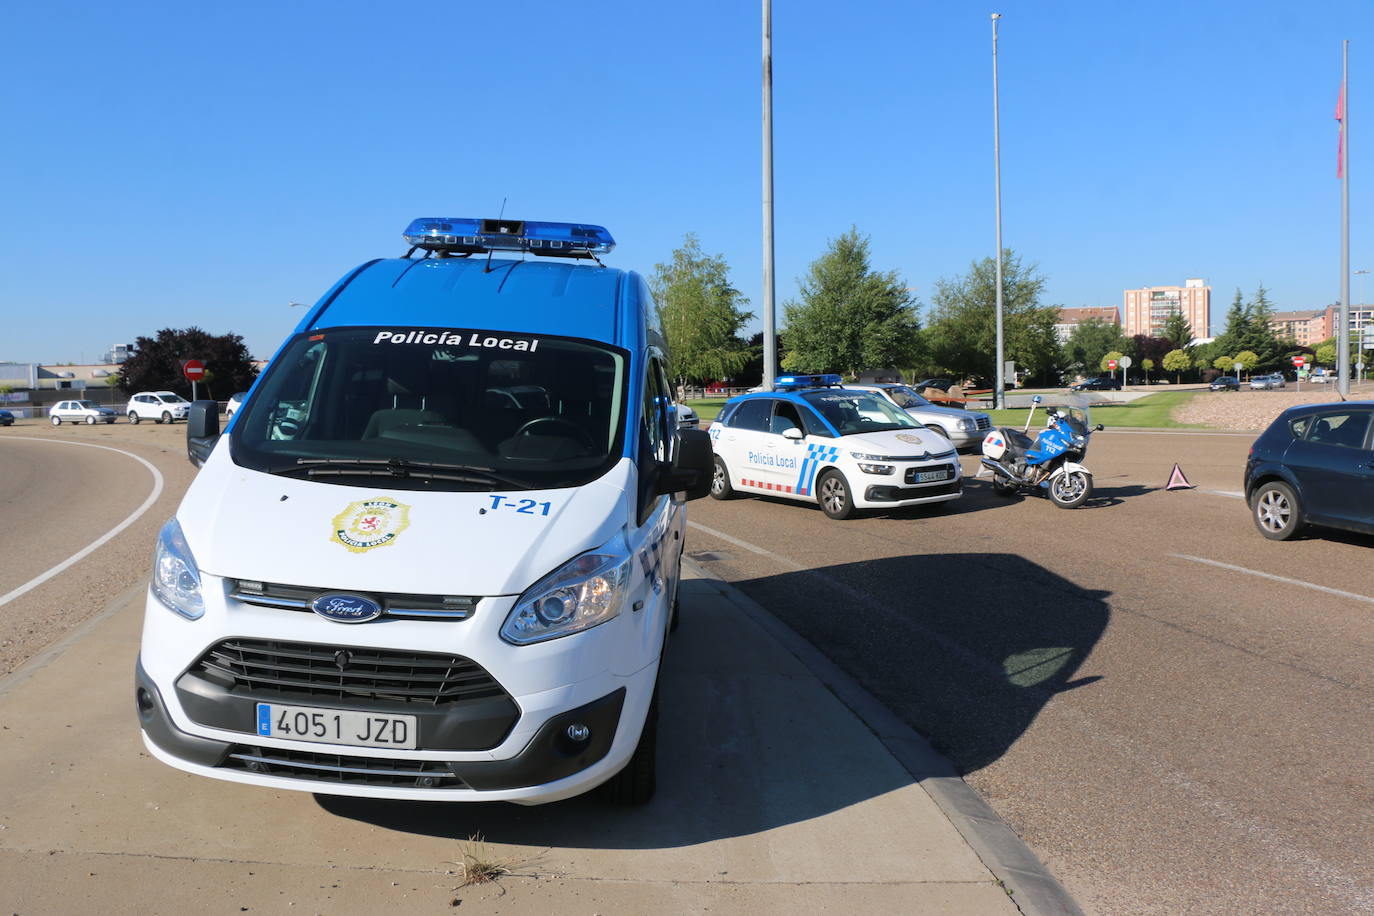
left=120, top=327, right=257, bottom=397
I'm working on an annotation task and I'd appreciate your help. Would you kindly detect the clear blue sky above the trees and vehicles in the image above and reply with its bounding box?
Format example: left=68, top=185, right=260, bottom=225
left=0, top=0, right=1374, bottom=363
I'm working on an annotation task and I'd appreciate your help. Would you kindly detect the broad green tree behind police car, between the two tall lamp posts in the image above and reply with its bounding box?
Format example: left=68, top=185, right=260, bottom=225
left=782, top=228, right=921, bottom=376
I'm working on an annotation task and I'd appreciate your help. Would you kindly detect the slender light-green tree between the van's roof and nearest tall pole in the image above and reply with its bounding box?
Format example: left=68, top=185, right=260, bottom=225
left=649, top=233, right=753, bottom=386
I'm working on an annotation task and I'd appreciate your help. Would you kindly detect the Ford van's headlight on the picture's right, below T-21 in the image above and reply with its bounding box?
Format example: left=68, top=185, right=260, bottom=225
left=502, top=536, right=631, bottom=645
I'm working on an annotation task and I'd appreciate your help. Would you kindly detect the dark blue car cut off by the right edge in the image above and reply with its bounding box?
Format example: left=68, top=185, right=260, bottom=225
left=1245, top=401, right=1374, bottom=541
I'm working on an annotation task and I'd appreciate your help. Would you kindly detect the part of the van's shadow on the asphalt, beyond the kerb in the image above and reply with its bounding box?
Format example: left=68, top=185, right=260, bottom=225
left=736, top=554, right=1110, bottom=773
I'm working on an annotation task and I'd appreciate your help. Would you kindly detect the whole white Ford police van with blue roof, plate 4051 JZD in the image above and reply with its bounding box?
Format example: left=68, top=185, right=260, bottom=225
left=136, top=220, right=710, bottom=805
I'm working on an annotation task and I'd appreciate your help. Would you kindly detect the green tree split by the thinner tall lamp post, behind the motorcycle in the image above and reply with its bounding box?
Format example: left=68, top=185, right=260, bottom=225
left=926, top=249, right=1063, bottom=379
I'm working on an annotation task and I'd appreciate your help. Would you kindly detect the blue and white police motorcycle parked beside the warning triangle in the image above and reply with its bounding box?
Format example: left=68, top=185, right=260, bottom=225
left=978, top=394, right=1102, bottom=509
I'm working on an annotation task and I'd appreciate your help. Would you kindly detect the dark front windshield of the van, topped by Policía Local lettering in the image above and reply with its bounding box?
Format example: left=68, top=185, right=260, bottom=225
left=229, top=327, right=628, bottom=490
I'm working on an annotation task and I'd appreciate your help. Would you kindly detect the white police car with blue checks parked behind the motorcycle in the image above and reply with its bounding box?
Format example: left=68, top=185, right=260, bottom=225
left=710, top=375, right=963, bottom=519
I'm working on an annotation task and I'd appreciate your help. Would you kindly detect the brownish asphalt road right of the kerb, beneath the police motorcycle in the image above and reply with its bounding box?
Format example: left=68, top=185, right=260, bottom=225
left=687, top=430, right=1374, bottom=913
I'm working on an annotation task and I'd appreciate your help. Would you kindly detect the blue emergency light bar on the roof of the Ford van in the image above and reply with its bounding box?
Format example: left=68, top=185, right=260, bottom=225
left=404, top=217, right=616, bottom=257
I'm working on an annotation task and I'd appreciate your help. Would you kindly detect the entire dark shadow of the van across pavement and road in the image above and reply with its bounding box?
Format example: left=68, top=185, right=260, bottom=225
left=316, top=553, right=1109, bottom=849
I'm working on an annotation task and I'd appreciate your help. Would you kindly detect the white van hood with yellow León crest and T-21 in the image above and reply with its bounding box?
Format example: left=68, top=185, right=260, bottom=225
left=177, top=439, right=635, bottom=596
